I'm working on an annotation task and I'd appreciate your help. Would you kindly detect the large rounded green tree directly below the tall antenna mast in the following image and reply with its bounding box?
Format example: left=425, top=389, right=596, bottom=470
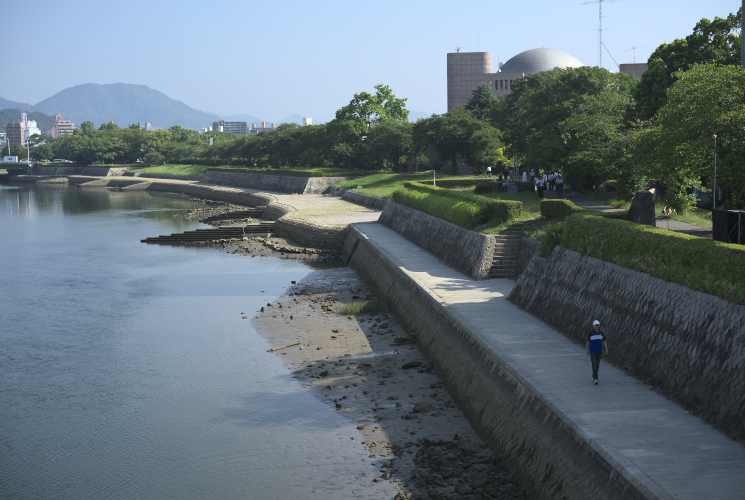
left=487, top=67, right=636, bottom=189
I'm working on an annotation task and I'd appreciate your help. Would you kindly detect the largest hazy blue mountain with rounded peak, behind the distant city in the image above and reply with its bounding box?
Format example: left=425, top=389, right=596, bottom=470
left=29, top=83, right=220, bottom=130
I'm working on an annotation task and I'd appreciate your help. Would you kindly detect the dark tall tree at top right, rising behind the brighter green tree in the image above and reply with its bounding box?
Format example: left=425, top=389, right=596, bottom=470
left=634, top=11, right=742, bottom=119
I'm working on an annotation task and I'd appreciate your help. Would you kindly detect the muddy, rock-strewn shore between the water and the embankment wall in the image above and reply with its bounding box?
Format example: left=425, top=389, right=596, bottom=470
left=244, top=242, right=523, bottom=499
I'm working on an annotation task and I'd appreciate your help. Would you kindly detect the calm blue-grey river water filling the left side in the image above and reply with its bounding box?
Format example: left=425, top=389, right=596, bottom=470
left=0, top=184, right=395, bottom=500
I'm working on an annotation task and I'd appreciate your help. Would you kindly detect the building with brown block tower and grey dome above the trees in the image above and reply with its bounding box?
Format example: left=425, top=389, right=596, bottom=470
left=448, top=48, right=584, bottom=111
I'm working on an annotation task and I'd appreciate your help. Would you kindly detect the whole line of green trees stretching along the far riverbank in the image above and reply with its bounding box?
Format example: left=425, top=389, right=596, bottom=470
left=13, top=9, right=745, bottom=210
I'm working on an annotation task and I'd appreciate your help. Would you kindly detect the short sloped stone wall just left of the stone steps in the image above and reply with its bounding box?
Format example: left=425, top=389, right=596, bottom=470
left=378, top=201, right=496, bottom=280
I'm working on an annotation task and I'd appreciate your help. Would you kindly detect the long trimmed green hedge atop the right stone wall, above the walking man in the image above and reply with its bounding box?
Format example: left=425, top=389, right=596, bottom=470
left=546, top=214, right=745, bottom=304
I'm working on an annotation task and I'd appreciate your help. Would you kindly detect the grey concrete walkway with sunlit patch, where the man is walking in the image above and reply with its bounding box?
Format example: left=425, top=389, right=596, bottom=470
left=355, top=223, right=745, bottom=500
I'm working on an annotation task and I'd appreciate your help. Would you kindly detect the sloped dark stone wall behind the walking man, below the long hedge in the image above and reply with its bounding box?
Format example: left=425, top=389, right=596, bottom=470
left=509, top=247, right=745, bottom=439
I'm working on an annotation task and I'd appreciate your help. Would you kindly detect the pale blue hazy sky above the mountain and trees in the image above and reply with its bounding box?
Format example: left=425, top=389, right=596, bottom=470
left=0, top=0, right=741, bottom=123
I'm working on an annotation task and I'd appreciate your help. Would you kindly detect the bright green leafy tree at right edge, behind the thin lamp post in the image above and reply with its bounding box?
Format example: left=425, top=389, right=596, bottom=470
left=632, top=64, right=745, bottom=211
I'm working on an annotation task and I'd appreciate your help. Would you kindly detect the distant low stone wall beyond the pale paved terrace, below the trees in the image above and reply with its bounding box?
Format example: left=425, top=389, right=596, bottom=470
left=202, top=170, right=348, bottom=194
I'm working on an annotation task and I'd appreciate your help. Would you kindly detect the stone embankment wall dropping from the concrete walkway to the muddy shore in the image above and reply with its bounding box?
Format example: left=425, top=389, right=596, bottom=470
left=343, top=225, right=654, bottom=500
